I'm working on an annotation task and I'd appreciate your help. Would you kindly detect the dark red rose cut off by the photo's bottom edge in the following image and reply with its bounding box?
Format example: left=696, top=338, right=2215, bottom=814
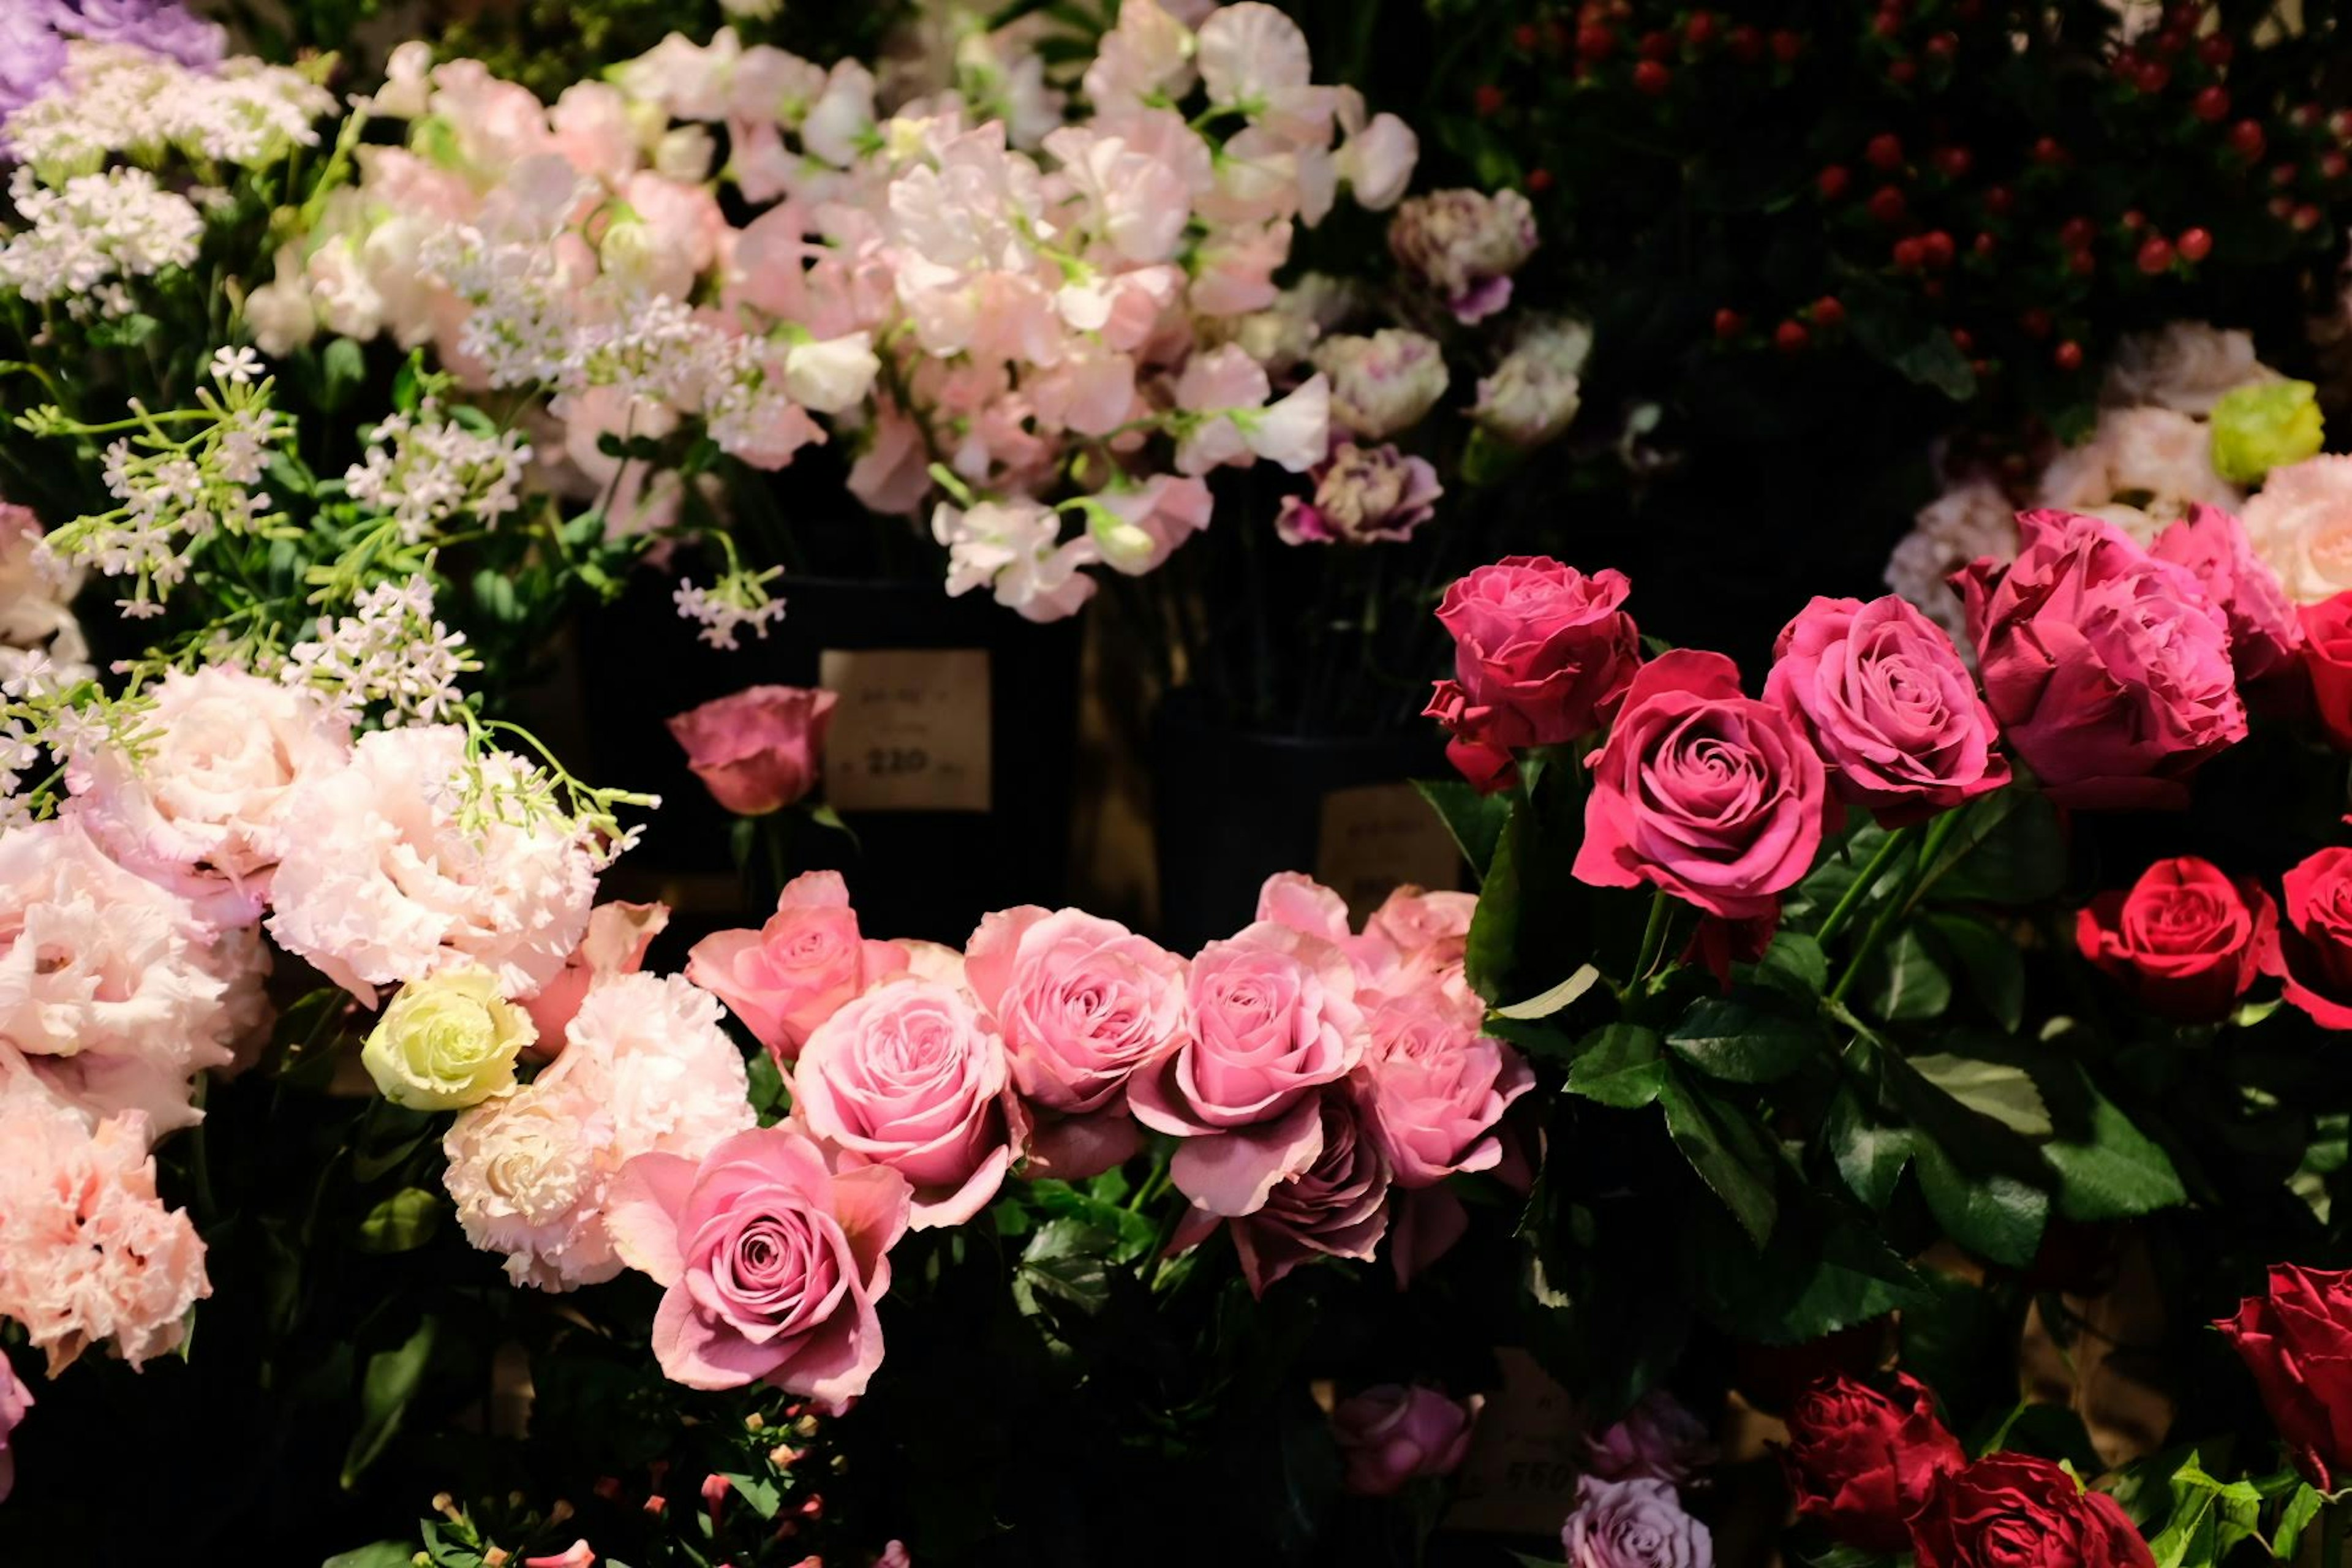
left=1912, top=1453, right=2157, bottom=1568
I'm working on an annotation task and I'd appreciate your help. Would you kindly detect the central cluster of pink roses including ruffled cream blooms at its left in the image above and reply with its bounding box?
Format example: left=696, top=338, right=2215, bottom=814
left=432, top=872, right=1534, bottom=1406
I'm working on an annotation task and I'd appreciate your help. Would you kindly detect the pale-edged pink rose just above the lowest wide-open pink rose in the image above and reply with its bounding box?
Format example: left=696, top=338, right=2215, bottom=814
left=790, top=980, right=1023, bottom=1229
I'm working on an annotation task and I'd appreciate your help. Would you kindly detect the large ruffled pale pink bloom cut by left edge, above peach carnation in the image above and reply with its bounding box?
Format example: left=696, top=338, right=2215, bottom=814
left=0, top=818, right=246, bottom=1133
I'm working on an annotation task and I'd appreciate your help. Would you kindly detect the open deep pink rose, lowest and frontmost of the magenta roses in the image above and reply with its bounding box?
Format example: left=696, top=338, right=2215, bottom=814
left=1576, top=649, right=1830, bottom=919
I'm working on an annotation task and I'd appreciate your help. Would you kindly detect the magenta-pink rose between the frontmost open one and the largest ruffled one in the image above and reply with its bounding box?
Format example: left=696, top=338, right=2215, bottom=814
left=1764, top=595, right=2008, bottom=827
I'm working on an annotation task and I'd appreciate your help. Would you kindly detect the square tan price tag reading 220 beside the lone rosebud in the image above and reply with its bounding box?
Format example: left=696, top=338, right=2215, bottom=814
left=818, top=649, right=990, bottom=811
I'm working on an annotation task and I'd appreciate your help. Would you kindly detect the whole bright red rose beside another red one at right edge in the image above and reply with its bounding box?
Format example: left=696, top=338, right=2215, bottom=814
left=2075, top=856, right=2279, bottom=1023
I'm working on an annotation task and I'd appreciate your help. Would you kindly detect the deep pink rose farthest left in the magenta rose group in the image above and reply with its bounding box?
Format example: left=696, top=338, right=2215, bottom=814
left=1428, top=555, right=1642, bottom=771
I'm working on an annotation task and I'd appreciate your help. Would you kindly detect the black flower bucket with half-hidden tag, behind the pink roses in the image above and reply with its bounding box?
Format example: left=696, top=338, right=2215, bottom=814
left=1153, top=691, right=1463, bottom=952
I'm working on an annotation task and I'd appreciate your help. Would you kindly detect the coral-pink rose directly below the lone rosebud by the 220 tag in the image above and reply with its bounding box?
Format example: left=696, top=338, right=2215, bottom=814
left=687, top=872, right=908, bottom=1063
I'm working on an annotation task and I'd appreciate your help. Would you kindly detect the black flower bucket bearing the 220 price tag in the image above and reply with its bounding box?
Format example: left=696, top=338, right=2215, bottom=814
left=581, top=573, right=1080, bottom=945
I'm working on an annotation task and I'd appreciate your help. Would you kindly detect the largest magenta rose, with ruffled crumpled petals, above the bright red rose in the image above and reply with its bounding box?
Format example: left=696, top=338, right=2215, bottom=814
left=1959, top=513, right=2246, bottom=809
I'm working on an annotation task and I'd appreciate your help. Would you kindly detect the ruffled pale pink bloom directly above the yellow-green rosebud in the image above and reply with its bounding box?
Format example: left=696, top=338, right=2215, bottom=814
left=271, top=724, right=595, bottom=1006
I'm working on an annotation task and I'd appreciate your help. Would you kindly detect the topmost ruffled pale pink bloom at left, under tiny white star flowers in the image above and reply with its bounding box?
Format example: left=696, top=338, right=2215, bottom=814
left=66, top=665, right=350, bottom=924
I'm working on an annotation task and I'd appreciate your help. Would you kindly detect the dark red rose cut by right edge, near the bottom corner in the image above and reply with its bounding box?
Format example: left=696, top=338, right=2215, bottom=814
left=2213, top=1262, right=2352, bottom=1493
